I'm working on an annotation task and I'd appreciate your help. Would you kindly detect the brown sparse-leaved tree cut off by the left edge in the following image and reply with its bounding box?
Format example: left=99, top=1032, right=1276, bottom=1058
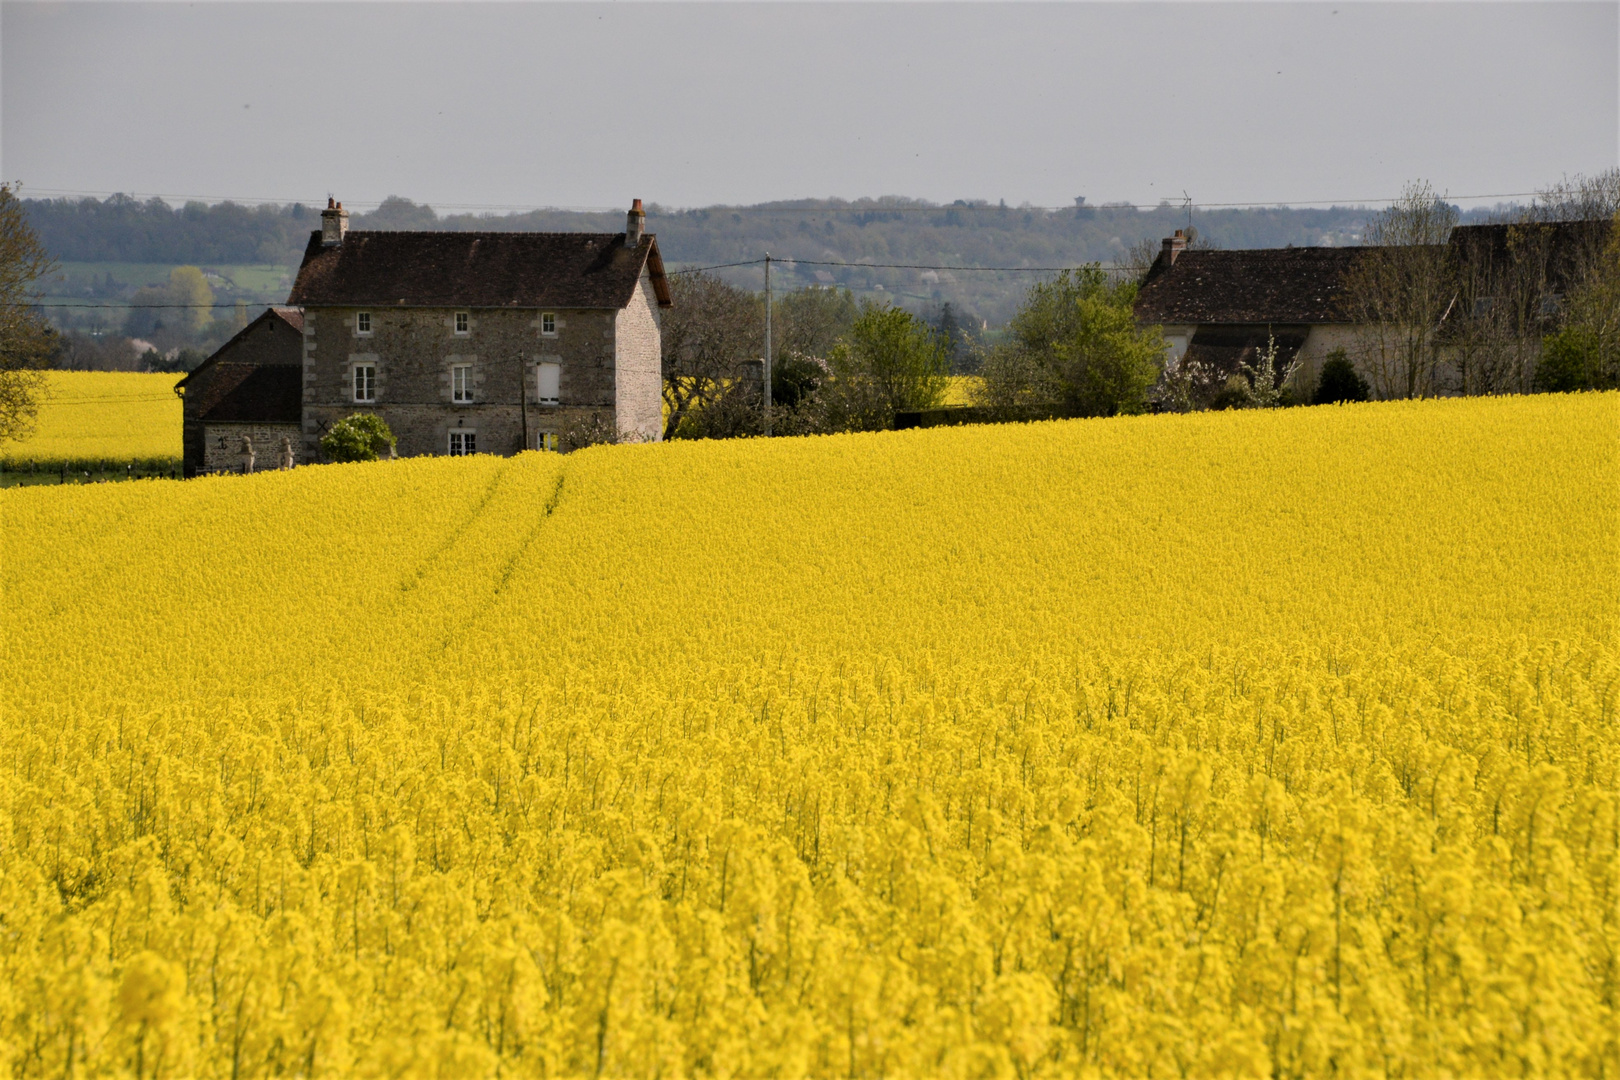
left=0, top=185, right=57, bottom=442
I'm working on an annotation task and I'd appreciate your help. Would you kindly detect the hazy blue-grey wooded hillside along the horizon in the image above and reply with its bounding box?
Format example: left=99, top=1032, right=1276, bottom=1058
left=26, top=196, right=1516, bottom=325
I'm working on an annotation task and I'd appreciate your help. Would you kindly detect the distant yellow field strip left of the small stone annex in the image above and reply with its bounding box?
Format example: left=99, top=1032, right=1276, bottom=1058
left=0, top=371, right=183, bottom=471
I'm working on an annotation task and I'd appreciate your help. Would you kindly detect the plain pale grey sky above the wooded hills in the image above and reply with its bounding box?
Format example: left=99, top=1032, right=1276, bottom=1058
left=0, top=0, right=1620, bottom=212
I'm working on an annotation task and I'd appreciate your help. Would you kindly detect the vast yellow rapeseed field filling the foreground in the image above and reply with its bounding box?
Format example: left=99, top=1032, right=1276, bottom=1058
left=0, top=393, right=1620, bottom=1077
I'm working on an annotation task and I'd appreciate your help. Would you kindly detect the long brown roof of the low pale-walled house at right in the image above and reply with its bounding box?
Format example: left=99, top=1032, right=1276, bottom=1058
left=1136, top=248, right=1367, bottom=325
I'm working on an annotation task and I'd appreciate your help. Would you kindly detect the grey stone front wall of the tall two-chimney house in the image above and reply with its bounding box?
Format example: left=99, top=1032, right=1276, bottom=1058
left=303, top=308, right=616, bottom=460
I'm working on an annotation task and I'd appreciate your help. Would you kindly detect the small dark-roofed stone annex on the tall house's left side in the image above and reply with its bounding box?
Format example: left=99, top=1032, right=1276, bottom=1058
left=175, top=308, right=311, bottom=476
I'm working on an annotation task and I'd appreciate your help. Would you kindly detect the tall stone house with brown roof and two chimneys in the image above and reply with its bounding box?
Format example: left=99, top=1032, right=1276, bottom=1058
left=288, top=199, right=671, bottom=460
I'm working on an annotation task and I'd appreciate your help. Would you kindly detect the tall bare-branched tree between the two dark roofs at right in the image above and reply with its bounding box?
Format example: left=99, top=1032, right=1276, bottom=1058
left=1343, top=181, right=1456, bottom=398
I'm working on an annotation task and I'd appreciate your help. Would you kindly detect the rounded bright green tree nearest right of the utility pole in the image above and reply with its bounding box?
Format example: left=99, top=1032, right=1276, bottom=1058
left=823, top=301, right=951, bottom=431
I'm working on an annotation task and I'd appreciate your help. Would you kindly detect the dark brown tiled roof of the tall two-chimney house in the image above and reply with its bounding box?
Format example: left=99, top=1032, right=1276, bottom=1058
left=287, top=232, right=671, bottom=308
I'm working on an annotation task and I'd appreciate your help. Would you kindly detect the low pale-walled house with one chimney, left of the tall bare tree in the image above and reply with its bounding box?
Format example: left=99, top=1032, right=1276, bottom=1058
left=1136, top=230, right=1366, bottom=399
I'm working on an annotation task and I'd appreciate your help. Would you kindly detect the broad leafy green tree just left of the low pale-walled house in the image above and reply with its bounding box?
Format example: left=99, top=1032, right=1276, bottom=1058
left=980, top=264, right=1166, bottom=416
